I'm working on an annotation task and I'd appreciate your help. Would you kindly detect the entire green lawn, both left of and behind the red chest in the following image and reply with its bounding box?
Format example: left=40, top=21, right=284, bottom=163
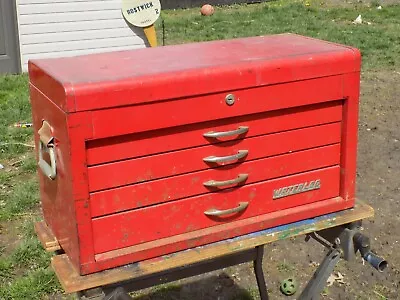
left=0, top=1, right=400, bottom=299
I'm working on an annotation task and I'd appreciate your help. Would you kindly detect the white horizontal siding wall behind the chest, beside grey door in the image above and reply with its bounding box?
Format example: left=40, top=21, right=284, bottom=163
left=17, top=0, right=145, bottom=71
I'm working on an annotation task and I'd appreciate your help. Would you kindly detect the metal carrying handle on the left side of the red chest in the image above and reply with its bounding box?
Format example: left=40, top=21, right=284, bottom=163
left=38, top=121, right=57, bottom=180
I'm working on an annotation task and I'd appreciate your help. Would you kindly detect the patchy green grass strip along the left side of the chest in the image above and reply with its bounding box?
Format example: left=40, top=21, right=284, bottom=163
left=0, top=75, right=60, bottom=300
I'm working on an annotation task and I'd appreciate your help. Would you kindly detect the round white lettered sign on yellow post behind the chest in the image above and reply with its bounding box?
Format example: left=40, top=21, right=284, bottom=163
left=122, top=0, right=161, bottom=47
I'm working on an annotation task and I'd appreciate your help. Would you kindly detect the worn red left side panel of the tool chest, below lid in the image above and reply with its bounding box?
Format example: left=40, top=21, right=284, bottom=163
left=30, top=85, right=80, bottom=269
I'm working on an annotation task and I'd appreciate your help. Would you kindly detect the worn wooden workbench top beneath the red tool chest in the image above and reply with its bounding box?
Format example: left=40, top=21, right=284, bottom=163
left=52, top=200, right=374, bottom=293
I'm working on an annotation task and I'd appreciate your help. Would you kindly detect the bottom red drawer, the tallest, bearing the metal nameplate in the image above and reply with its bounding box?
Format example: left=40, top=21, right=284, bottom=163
left=92, top=166, right=340, bottom=254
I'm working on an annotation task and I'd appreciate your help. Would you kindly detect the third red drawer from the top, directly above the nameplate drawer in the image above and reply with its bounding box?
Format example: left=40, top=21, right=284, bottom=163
left=90, top=144, right=340, bottom=217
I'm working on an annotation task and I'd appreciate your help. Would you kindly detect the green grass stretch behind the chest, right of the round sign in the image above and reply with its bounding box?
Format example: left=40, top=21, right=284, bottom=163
left=158, top=1, right=400, bottom=70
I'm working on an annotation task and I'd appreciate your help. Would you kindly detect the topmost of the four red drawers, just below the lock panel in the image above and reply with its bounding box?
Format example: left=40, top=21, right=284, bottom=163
left=86, top=101, right=342, bottom=166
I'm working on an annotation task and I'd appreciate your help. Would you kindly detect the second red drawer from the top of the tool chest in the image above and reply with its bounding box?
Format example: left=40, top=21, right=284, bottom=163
left=88, top=122, right=341, bottom=192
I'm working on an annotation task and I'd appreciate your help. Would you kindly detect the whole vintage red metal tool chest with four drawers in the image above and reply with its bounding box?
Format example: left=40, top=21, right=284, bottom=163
left=29, top=34, right=360, bottom=274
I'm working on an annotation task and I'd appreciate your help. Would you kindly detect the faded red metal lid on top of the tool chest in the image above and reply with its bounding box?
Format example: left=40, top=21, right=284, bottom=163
left=29, top=34, right=360, bottom=112
